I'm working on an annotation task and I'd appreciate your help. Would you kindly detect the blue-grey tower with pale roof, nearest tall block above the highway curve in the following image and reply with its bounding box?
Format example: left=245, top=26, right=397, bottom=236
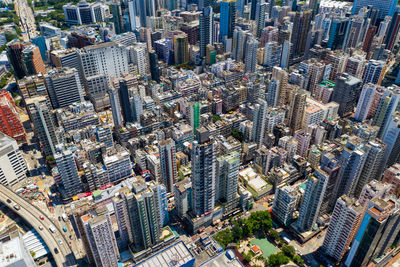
left=54, top=150, right=82, bottom=198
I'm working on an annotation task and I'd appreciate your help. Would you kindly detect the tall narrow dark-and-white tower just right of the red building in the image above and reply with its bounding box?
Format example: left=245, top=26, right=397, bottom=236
left=26, top=96, right=58, bottom=156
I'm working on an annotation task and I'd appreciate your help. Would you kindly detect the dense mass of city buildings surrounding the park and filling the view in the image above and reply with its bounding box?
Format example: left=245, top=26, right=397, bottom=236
left=0, top=0, right=400, bottom=267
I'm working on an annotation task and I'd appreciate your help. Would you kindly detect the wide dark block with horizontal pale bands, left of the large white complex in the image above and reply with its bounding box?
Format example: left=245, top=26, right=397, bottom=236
left=45, top=67, right=83, bottom=109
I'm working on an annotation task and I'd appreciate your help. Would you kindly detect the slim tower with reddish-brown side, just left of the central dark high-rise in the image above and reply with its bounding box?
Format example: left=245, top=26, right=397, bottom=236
left=158, top=138, right=178, bottom=192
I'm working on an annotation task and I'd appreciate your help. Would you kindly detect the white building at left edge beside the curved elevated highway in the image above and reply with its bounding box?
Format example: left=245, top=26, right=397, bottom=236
left=0, top=132, right=28, bottom=189
